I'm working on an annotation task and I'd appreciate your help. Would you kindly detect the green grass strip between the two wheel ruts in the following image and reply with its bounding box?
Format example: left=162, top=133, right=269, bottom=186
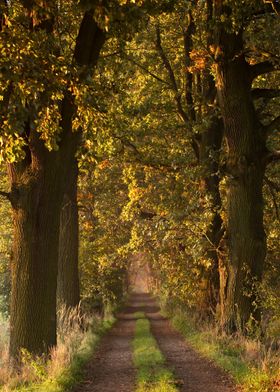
left=133, top=312, right=177, bottom=392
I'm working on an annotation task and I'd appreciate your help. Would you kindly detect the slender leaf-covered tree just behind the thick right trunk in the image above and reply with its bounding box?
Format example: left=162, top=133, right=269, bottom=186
left=156, top=3, right=224, bottom=311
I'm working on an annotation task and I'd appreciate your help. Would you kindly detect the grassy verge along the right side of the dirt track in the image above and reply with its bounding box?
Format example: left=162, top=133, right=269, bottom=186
left=165, top=310, right=280, bottom=392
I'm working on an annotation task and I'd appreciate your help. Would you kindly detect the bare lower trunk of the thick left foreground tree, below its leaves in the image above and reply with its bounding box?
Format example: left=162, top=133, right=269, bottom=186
left=10, top=172, right=61, bottom=357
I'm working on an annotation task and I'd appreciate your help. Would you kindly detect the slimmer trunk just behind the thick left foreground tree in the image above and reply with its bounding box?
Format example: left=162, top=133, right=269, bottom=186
left=57, top=160, right=80, bottom=308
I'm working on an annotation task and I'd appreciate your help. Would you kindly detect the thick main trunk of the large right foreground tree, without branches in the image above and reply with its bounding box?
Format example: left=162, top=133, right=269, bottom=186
left=216, top=31, right=266, bottom=330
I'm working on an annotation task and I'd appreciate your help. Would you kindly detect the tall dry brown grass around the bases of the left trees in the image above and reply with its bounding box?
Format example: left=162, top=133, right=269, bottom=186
left=0, top=306, right=101, bottom=392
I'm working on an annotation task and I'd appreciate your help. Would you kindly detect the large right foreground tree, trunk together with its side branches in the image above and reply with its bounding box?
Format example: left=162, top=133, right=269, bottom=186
left=213, top=1, right=279, bottom=330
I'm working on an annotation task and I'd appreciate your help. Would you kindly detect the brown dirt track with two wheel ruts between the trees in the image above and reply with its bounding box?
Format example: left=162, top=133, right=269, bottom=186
left=73, top=294, right=238, bottom=392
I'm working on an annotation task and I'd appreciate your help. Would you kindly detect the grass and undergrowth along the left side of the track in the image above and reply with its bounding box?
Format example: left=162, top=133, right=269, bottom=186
left=0, top=308, right=115, bottom=392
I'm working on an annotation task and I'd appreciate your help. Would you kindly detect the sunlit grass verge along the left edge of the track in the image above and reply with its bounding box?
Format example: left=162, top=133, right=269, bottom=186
left=0, top=316, right=115, bottom=392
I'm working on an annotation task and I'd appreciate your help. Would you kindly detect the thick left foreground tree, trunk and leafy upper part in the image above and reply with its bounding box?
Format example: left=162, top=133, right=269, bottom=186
left=0, top=2, right=105, bottom=357
